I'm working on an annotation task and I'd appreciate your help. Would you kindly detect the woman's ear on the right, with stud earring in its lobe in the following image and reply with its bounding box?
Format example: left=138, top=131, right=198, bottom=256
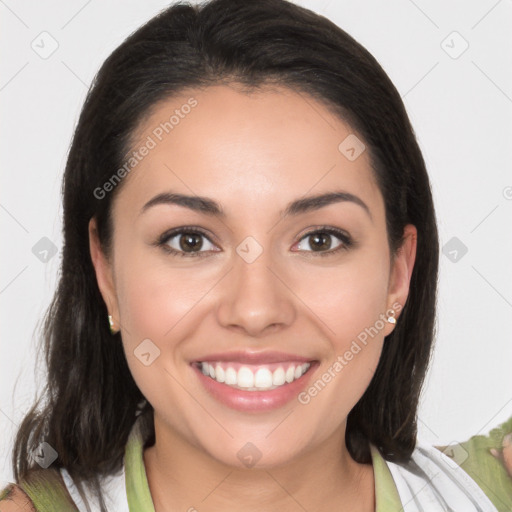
left=386, top=224, right=418, bottom=335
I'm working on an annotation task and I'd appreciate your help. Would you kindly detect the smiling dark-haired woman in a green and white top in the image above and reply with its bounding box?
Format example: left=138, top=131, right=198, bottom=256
left=0, top=0, right=512, bottom=512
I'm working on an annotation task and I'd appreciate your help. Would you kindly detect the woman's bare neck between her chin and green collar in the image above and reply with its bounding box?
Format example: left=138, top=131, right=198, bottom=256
left=144, top=419, right=375, bottom=512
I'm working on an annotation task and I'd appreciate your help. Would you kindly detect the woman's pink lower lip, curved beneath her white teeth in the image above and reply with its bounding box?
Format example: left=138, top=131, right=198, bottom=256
left=192, top=361, right=318, bottom=412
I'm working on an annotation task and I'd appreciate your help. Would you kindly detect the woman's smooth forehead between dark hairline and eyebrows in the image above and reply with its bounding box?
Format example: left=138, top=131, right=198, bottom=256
left=116, top=86, right=382, bottom=220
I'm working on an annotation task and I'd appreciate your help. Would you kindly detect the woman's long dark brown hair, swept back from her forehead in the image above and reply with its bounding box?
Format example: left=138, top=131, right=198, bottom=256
left=13, top=0, right=439, bottom=508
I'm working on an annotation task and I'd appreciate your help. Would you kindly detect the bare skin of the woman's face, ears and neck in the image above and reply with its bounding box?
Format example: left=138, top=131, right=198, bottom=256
left=89, top=86, right=416, bottom=512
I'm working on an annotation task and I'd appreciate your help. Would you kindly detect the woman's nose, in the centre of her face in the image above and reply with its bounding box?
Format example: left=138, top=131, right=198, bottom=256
left=217, top=246, right=296, bottom=338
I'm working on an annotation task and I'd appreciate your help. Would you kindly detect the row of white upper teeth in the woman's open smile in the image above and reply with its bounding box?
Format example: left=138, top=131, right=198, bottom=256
left=196, top=362, right=311, bottom=391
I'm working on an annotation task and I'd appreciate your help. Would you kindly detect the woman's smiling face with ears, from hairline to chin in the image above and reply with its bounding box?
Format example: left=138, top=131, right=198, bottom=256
left=90, top=86, right=415, bottom=467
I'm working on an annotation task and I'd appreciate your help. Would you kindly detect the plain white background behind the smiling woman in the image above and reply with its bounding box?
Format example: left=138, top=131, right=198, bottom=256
left=0, top=0, right=512, bottom=483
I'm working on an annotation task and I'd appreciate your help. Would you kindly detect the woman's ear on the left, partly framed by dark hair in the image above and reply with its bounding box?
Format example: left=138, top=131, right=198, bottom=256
left=89, top=217, right=120, bottom=330
